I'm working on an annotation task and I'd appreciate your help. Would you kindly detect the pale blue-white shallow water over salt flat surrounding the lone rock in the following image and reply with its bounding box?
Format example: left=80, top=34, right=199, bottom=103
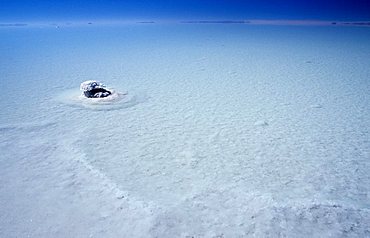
left=0, top=24, right=370, bottom=237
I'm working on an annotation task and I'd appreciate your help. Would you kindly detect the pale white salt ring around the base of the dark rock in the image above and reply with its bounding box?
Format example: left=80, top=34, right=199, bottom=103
left=56, top=89, right=146, bottom=111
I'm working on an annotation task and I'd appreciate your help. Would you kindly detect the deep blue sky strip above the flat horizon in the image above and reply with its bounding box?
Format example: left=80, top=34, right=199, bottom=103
left=0, top=0, right=370, bottom=21
